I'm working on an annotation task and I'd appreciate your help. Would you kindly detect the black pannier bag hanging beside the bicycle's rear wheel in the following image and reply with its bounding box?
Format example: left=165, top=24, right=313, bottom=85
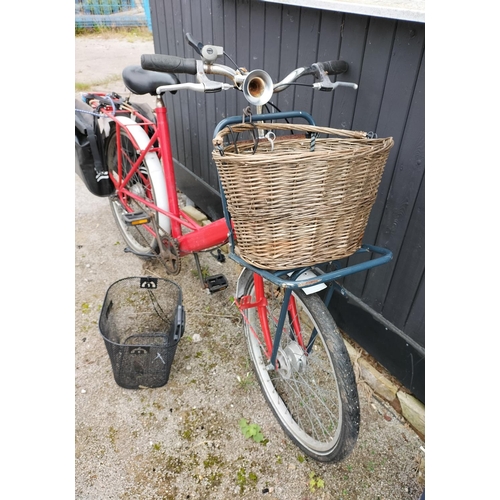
left=75, top=99, right=115, bottom=196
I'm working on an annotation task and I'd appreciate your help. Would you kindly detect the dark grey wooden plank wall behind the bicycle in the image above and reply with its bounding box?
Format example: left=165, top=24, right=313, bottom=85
left=146, top=0, right=425, bottom=401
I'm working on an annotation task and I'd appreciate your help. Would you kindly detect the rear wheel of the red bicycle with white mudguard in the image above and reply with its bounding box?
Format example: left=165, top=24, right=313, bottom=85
left=106, top=117, right=170, bottom=256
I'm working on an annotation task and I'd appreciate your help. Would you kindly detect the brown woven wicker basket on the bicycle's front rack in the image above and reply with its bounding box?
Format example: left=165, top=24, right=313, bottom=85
left=213, top=123, right=394, bottom=269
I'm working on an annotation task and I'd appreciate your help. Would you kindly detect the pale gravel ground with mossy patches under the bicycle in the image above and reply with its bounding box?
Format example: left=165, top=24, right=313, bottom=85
left=75, top=32, right=425, bottom=500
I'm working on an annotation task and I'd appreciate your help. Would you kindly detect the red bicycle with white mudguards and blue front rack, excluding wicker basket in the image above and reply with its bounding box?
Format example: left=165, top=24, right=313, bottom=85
left=76, top=35, right=392, bottom=462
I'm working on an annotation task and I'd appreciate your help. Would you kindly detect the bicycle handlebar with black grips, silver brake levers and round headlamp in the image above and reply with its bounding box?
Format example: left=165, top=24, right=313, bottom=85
left=141, top=33, right=358, bottom=105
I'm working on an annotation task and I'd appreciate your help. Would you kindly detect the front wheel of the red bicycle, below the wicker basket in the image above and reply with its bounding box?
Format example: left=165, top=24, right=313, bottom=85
left=238, top=270, right=360, bottom=462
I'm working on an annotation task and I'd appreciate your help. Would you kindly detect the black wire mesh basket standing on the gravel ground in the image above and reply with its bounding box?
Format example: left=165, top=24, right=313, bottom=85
left=99, top=277, right=185, bottom=389
